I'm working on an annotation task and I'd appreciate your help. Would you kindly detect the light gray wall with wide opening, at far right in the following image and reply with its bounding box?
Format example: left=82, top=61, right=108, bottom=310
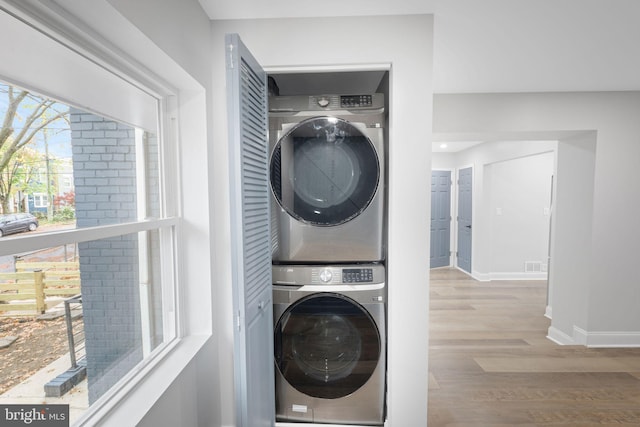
left=434, top=92, right=640, bottom=346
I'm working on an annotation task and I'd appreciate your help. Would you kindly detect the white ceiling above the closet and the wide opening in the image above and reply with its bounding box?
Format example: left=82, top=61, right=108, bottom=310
left=199, top=0, right=640, bottom=93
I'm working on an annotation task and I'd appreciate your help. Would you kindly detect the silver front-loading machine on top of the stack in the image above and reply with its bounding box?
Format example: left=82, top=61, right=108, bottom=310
left=269, top=94, right=385, bottom=264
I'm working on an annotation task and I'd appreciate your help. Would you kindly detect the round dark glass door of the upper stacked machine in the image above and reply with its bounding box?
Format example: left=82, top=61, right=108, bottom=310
left=271, top=117, right=380, bottom=226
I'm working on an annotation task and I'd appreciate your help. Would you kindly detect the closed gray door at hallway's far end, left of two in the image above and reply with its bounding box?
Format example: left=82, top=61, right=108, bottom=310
left=430, top=171, right=451, bottom=268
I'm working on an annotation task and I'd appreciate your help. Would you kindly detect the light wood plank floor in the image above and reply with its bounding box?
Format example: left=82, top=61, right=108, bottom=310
left=428, top=268, right=640, bottom=427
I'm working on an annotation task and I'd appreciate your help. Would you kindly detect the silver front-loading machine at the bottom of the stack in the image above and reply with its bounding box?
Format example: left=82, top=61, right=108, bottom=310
left=273, top=264, right=386, bottom=426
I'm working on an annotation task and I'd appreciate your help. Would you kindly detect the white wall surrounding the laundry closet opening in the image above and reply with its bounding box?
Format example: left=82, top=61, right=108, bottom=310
left=212, top=15, right=433, bottom=427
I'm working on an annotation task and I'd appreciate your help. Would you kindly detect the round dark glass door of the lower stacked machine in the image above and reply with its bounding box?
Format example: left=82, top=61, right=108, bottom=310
left=274, top=293, right=381, bottom=399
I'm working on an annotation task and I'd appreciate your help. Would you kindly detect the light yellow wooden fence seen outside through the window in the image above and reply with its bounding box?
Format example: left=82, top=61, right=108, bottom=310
left=0, top=261, right=80, bottom=314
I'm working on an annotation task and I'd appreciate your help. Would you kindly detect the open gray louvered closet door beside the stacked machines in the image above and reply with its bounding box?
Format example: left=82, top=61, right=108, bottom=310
left=225, top=34, right=275, bottom=427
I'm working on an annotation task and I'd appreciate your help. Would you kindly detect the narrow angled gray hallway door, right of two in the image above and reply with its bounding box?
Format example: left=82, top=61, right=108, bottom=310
left=457, top=168, right=473, bottom=273
